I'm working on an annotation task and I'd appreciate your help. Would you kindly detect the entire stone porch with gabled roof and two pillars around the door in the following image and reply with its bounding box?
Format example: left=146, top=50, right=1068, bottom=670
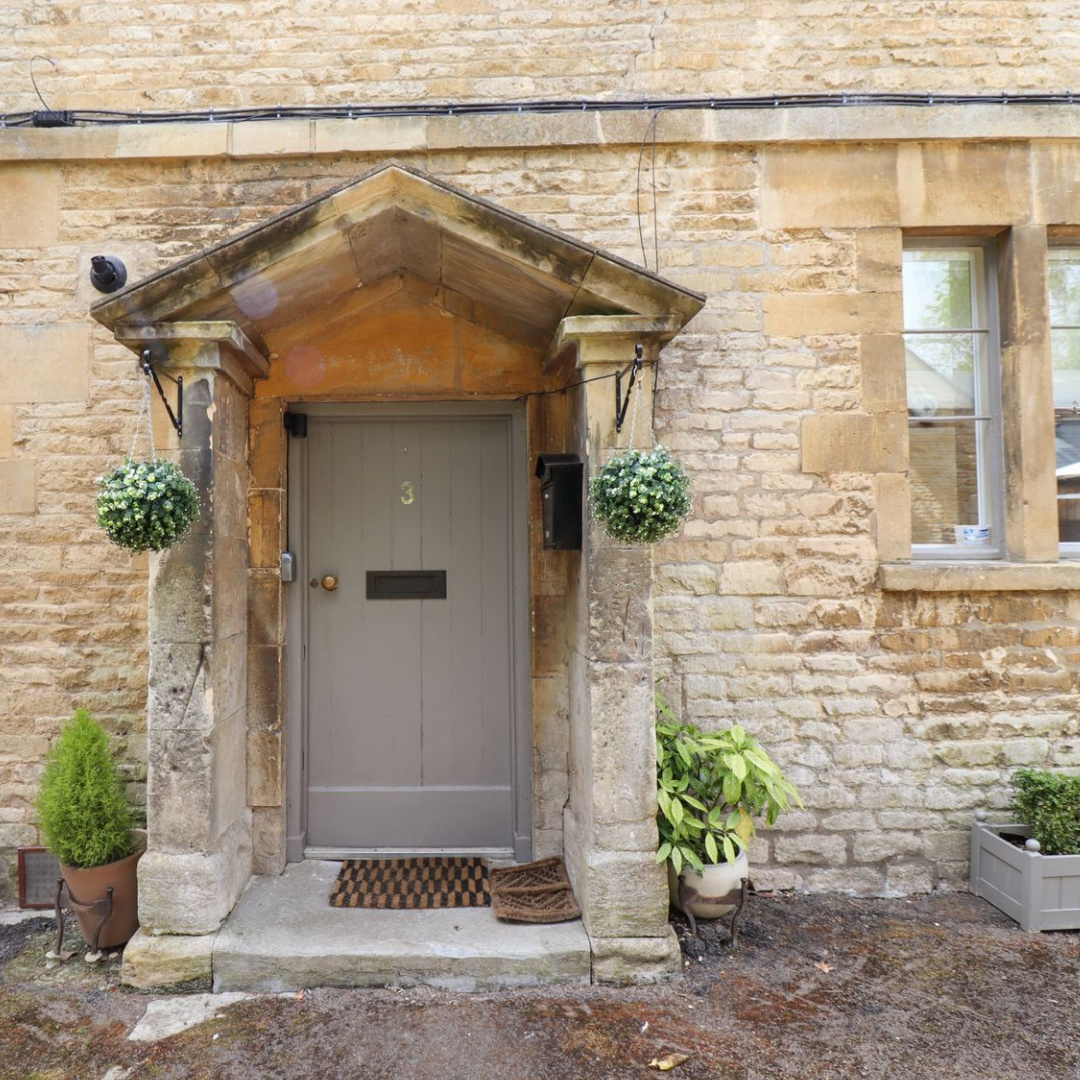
left=91, top=163, right=704, bottom=981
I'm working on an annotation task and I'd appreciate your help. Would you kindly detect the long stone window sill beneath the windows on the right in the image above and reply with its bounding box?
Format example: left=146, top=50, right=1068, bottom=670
left=879, top=561, right=1080, bottom=593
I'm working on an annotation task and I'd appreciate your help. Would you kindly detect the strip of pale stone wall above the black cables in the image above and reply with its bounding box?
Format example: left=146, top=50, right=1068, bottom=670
left=0, top=0, right=1080, bottom=110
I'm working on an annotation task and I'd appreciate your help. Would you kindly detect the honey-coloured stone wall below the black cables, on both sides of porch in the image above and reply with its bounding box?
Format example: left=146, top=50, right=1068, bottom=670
left=0, top=111, right=1080, bottom=892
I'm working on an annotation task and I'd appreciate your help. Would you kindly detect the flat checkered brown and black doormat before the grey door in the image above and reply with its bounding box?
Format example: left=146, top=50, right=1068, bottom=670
left=330, top=855, right=491, bottom=909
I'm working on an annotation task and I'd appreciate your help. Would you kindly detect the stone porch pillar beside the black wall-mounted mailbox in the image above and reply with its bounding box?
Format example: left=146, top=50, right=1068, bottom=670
left=554, top=315, right=679, bottom=983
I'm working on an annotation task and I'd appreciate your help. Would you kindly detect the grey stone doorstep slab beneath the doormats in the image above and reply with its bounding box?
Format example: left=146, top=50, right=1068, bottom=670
left=213, top=861, right=592, bottom=993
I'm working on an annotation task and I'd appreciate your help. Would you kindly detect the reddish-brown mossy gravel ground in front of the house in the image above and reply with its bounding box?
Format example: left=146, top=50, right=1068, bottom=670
left=0, top=895, right=1080, bottom=1080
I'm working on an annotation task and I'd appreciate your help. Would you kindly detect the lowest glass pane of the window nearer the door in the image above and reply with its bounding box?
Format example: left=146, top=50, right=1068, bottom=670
left=909, top=419, right=993, bottom=544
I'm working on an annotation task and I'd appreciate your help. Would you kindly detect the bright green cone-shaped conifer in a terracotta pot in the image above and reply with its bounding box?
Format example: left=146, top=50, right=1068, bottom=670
left=37, top=708, right=143, bottom=948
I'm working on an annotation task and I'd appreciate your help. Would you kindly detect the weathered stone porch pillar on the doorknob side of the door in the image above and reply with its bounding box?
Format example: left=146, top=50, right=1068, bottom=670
left=117, top=323, right=267, bottom=934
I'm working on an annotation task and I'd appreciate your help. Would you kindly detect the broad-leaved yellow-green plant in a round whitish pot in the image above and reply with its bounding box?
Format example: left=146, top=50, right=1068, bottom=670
left=657, top=702, right=802, bottom=918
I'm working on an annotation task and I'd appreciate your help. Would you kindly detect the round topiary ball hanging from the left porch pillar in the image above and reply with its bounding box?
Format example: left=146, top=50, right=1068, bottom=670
left=97, top=461, right=199, bottom=552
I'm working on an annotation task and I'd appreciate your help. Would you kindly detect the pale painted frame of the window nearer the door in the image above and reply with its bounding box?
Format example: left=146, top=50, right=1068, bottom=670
left=904, top=237, right=1002, bottom=561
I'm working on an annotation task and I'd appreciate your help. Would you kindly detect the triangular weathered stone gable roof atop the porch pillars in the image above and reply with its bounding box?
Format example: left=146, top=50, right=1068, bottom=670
left=91, top=162, right=704, bottom=357
